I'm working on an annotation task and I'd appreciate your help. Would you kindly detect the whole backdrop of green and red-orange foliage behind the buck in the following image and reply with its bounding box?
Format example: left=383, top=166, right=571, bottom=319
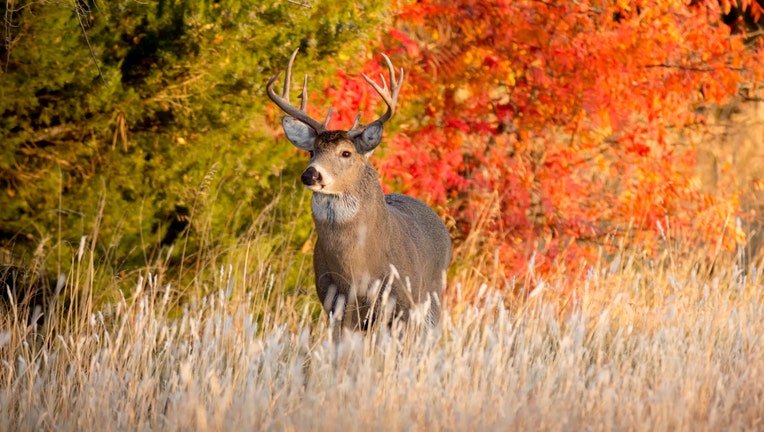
left=0, top=0, right=764, bottom=304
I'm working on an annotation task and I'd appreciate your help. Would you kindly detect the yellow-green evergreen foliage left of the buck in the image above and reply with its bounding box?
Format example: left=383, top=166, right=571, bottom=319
left=0, top=0, right=389, bottom=294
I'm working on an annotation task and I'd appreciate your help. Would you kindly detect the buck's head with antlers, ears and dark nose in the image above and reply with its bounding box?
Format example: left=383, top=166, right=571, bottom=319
left=266, top=50, right=403, bottom=195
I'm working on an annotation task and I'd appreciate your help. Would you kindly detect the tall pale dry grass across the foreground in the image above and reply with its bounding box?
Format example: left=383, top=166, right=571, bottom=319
left=0, top=219, right=764, bottom=431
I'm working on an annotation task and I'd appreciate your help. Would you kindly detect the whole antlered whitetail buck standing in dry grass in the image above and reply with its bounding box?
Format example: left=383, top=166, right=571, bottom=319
left=266, top=50, right=451, bottom=331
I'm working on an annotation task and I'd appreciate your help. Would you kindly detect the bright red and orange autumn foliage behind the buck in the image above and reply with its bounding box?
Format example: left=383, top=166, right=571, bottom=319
left=328, top=0, right=761, bottom=282
